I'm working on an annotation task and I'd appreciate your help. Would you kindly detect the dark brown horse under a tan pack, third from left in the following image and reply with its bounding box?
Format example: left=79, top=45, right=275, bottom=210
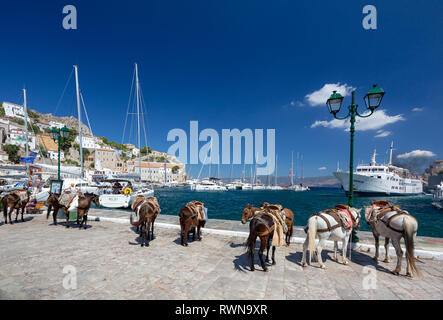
left=129, top=195, right=161, bottom=247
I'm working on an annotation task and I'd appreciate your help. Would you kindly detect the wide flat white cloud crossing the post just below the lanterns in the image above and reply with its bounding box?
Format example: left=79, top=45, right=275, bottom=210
left=311, top=110, right=405, bottom=131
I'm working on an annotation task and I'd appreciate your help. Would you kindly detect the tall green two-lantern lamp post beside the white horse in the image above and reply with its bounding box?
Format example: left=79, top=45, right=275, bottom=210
left=326, top=84, right=385, bottom=242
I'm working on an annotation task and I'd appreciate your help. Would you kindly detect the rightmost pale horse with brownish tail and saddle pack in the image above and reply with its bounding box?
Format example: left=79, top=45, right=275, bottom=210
left=365, top=201, right=421, bottom=277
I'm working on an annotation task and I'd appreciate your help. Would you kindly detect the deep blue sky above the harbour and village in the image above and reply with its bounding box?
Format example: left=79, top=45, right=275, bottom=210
left=0, top=0, right=443, bottom=176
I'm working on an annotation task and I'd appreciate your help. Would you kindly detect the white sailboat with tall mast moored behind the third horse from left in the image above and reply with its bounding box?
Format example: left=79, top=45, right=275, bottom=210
left=99, top=63, right=154, bottom=208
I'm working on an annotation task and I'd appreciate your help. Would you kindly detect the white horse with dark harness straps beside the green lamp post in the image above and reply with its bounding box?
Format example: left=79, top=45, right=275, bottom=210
left=302, top=207, right=361, bottom=269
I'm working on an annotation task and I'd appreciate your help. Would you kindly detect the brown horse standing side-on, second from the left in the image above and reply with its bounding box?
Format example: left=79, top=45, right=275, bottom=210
left=46, top=192, right=100, bottom=229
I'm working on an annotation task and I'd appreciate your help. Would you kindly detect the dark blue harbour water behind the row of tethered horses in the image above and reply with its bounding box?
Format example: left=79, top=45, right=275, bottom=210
left=127, top=188, right=443, bottom=238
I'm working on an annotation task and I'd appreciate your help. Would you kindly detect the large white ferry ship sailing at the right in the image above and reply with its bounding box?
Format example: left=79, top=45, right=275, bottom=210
left=334, top=144, right=423, bottom=196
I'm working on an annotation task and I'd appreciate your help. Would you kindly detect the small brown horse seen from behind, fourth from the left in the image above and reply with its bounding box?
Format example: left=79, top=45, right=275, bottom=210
left=178, top=201, right=206, bottom=247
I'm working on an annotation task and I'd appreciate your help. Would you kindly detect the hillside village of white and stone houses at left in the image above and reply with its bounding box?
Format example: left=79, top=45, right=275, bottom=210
left=0, top=102, right=186, bottom=183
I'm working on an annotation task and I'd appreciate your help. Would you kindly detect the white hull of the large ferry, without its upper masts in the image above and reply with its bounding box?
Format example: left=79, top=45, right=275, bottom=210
left=334, top=171, right=423, bottom=197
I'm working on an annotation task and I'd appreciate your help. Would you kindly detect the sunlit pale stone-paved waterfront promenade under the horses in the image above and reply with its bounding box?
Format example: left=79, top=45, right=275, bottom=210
left=0, top=209, right=443, bottom=300
